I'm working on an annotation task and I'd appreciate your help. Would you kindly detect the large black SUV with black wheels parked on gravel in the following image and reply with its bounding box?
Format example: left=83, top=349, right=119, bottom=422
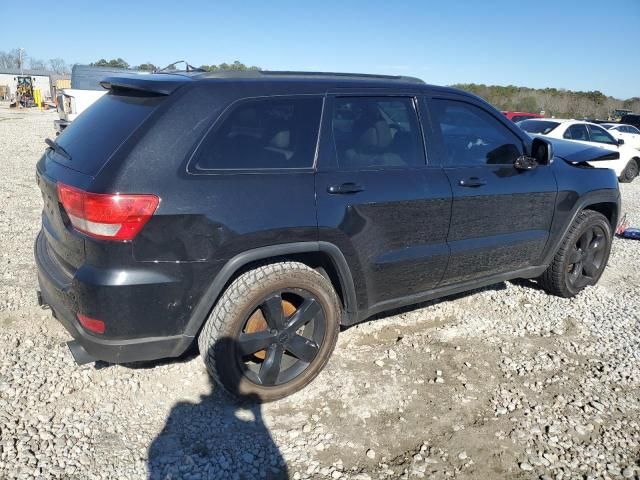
left=35, top=72, right=620, bottom=400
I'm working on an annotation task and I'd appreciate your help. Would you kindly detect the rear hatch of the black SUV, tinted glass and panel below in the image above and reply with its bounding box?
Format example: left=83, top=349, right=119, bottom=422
left=37, top=77, right=180, bottom=270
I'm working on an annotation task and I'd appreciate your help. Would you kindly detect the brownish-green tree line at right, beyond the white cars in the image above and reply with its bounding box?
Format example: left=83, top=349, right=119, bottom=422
left=452, top=83, right=640, bottom=120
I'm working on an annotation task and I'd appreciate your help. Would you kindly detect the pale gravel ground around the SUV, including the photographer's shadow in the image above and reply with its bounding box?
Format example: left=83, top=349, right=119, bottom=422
left=0, top=107, right=640, bottom=479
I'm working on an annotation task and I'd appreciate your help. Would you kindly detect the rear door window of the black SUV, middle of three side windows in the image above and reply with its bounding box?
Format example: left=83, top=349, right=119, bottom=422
left=331, top=97, right=425, bottom=168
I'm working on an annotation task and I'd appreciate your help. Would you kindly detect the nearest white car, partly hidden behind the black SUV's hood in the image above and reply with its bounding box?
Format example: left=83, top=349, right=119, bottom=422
left=517, top=118, right=640, bottom=182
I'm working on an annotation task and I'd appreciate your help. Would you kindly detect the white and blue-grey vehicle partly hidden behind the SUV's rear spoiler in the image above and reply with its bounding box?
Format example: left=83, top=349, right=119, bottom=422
left=53, top=65, right=148, bottom=135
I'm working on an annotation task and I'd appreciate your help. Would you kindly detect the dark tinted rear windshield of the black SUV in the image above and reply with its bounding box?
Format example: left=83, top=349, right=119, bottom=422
left=53, top=93, right=166, bottom=175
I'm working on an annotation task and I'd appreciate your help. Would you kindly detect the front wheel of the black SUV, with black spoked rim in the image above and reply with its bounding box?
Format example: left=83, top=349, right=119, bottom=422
left=538, top=210, right=613, bottom=298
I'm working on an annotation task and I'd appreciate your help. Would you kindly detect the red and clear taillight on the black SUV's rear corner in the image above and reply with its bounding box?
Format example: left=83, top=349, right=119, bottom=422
left=58, top=183, right=160, bottom=241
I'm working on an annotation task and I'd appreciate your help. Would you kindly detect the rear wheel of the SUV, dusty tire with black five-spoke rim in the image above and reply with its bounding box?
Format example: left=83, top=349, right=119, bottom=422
left=198, top=262, right=341, bottom=402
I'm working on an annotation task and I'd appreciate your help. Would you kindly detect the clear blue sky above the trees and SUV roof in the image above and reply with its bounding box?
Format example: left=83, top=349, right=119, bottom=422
left=0, top=0, right=640, bottom=99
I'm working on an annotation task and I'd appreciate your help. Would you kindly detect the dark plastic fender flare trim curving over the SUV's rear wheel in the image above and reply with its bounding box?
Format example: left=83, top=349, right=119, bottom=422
left=183, top=242, right=357, bottom=337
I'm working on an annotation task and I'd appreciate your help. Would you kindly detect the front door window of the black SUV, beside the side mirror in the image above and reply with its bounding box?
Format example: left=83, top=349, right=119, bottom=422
left=430, top=100, right=523, bottom=166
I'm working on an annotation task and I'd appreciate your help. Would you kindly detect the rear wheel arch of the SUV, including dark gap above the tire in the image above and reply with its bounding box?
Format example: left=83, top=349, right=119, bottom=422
left=184, top=242, right=357, bottom=337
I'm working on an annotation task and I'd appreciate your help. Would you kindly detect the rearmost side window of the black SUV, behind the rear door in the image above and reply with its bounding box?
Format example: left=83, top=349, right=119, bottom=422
left=194, top=97, right=322, bottom=170
